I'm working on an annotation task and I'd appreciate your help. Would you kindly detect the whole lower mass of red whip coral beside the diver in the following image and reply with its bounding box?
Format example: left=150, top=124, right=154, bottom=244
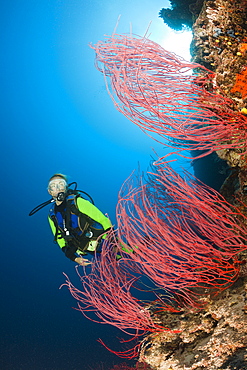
left=62, top=162, right=247, bottom=358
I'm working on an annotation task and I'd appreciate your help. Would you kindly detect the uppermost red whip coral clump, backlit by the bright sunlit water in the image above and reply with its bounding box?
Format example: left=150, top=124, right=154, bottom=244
left=91, top=34, right=247, bottom=155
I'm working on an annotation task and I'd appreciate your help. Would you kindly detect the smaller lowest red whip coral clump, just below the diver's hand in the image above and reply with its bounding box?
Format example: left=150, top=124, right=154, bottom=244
left=60, top=232, right=164, bottom=336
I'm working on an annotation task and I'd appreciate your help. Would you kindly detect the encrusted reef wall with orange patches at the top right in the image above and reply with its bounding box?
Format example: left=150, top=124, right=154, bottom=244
left=191, top=0, right=247, bottom=168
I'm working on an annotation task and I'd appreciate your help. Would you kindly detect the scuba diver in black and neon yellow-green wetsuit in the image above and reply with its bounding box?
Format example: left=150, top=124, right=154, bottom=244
left=29, top=173, right=112, bottom=266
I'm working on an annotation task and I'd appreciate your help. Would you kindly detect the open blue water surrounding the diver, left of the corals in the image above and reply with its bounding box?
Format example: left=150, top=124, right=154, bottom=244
left=0, top=0, right=228, bottom=370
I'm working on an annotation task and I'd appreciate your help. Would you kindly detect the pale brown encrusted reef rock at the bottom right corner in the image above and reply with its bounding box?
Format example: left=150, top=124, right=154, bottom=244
left=140, top=277, right=247, bottom=370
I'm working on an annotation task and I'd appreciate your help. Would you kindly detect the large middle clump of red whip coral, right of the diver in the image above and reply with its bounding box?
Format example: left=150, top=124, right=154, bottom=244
left=117, top=163, right=247, bottom=306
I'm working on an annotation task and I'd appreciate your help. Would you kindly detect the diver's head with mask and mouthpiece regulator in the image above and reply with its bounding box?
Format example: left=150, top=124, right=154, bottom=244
left=47, top=173, right=68, bottom=205
